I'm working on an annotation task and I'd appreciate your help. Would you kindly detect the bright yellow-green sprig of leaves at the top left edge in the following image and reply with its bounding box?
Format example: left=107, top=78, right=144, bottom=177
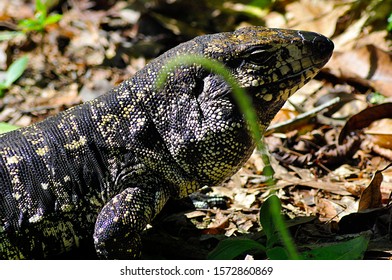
left=18, top=0, right=62, bottom=33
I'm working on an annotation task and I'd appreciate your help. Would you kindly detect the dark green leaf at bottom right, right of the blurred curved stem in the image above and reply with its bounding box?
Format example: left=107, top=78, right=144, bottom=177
left=302, top=235, right=370, bottom=260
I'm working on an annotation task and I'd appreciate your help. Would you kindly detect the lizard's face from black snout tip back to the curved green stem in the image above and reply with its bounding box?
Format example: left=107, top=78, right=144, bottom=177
left=204, top=27, right=334, bottom=124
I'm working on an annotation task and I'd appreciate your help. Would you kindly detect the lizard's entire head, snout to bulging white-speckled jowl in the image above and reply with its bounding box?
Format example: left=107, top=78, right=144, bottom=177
left=135, top=27, right=333, bottom=187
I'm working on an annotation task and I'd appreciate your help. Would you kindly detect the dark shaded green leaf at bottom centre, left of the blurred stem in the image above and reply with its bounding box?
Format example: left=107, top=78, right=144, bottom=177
left=208, top=239, right=265, bottom=260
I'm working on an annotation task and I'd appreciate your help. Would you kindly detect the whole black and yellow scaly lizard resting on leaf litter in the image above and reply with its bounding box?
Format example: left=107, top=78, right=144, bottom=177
left=0, top=27, right=333, bottom=259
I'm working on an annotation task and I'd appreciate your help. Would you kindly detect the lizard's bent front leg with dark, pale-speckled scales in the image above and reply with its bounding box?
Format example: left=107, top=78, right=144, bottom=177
left=94, top=187, right=169, bottom=259
